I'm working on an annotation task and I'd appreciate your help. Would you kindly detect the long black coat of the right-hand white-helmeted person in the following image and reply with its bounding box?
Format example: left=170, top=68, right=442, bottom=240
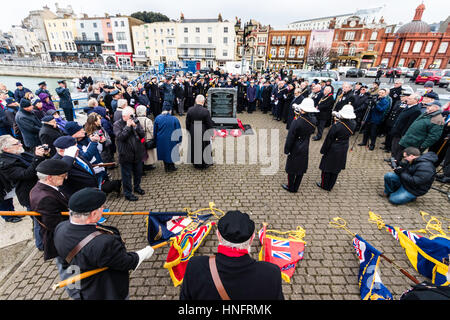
left=319, top=120, right=356, bottom=174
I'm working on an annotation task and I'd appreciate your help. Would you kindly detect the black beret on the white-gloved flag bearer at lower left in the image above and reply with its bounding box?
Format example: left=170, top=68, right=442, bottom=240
left=69, top=188, right=106, bottom=213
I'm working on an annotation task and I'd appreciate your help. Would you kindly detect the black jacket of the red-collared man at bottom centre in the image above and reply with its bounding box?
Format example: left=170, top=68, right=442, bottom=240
left=180, top=253, right=284, bottom=300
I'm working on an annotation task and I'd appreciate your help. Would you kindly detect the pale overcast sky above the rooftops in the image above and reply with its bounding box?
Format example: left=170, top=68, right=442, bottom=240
left=0, top=0, right=450, bottom=32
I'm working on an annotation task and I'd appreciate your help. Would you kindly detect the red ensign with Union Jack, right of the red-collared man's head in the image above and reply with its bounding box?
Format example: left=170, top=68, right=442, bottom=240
left=258, top=226, right=305, bottom=283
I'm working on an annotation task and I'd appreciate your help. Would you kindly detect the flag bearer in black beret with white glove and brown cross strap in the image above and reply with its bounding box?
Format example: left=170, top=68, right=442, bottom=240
left=55, top=188, right=154, bottom=300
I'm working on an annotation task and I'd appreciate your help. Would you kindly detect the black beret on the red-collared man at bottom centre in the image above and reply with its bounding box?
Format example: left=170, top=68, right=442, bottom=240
left=217, top=211, right=255, bottom=243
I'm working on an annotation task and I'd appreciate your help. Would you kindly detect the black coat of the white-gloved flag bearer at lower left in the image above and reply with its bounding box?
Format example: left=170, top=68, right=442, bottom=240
left=55, top=221, right=139, bottom=300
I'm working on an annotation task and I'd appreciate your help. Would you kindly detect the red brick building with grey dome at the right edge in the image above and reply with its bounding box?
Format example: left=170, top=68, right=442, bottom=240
left=376, top=4, right=450, bottom=69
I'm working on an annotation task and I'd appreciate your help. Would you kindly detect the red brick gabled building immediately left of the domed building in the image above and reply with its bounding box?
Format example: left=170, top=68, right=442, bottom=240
left=330, top=16, right=386, bottom=68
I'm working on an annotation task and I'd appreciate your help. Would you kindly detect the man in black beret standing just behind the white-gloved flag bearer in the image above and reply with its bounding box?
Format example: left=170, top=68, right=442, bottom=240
left=30, top=159, right=70, bottom=265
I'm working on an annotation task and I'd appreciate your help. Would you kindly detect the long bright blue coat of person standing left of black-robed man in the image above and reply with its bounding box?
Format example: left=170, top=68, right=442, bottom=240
left=153, top=114, right=183, bottom=163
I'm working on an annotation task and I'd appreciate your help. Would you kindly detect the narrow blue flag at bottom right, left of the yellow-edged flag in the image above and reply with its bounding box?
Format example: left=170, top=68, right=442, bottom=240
left=353, top=234, right=392, bottom=300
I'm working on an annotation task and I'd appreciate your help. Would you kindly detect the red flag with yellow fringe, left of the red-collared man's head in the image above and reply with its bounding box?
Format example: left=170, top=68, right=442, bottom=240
left=164, top=222, right=216, bottom=287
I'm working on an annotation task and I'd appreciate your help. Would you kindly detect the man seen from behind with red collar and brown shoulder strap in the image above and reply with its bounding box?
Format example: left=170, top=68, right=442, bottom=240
left=180, top=211, right=284, bottom=300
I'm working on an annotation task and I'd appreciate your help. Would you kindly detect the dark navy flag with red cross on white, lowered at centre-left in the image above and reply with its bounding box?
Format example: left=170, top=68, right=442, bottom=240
left=147, top=211, right=212, bottom=246
